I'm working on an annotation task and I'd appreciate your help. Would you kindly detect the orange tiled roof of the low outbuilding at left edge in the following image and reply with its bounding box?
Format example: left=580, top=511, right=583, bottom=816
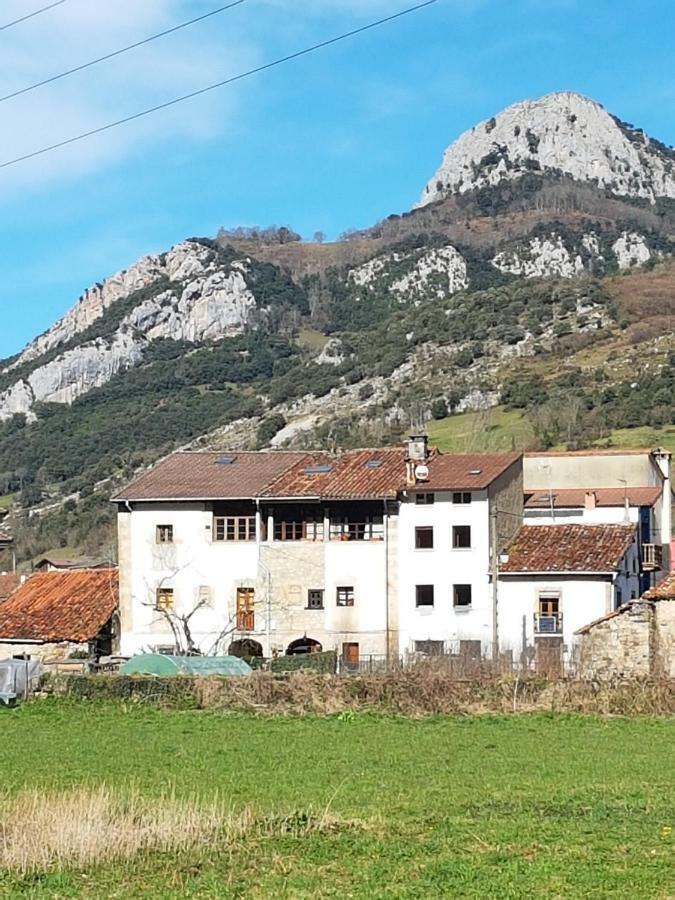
left=0, top=569, right=119, bottom=643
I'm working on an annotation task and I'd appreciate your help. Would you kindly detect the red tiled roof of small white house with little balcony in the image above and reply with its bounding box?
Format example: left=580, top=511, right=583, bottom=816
left=499, top=525, right=636, bottom=575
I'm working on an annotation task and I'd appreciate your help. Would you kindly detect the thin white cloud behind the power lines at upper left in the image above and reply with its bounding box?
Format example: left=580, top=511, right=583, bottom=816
left=0, top=0, right=259, bottom=196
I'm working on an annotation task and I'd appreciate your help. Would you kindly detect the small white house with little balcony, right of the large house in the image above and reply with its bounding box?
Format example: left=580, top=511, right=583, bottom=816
left=497, top=524, right=641, bottom=671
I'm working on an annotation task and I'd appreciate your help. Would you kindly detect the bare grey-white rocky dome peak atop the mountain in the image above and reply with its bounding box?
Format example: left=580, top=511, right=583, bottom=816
left=418, top=91, right=675, bottom=206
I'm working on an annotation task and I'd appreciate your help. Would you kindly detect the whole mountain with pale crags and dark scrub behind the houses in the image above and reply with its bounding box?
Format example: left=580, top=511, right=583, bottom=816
left=0, top=88, right=675, bottom=555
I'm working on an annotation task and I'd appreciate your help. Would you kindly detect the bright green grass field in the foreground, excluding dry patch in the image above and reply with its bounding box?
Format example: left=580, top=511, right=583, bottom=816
left=0, top=702, right=675, bottom=898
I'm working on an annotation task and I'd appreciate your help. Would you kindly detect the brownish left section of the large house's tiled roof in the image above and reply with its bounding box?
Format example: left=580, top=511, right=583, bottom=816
left=113, top=451, right=306, bottom=501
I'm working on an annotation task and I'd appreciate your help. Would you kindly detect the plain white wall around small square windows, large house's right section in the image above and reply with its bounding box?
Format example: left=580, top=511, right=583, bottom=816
left=399, top=491, right=492, bottom=654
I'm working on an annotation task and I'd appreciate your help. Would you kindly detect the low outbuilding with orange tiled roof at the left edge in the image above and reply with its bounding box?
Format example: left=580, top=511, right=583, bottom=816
left=0, top=569, right=119, bottom=662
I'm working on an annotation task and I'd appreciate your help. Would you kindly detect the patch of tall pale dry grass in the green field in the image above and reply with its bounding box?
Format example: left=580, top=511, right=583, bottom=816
left=0, top=786, right=358, bottom=875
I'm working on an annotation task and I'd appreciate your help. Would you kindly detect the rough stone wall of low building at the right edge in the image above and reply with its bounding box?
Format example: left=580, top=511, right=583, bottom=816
left=576, top=600, right=675, bottom=678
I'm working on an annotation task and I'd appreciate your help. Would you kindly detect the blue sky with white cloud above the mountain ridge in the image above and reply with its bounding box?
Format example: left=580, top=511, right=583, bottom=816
left=0, top=0, right=675, bottom=357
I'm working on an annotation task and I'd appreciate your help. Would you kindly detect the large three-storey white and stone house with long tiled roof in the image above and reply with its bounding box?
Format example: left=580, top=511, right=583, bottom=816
left=114, top=438, right=523, bottom=663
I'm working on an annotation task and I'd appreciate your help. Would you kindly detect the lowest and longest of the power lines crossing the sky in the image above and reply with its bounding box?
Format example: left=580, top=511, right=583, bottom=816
left=0, top=0, right=437, bottom=169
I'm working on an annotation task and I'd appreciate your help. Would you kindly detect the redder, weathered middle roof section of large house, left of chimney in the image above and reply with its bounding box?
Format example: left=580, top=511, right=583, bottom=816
left=265, top=448, right=405, bottom=500
